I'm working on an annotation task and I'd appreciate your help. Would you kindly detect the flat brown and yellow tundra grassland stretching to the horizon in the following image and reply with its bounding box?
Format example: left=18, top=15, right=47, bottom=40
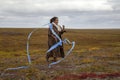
left=0, top=28, right=120, bottom=80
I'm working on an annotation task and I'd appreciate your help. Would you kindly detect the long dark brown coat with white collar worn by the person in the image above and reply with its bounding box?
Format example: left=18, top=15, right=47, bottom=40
left=47, top=25, right=65, bottom=61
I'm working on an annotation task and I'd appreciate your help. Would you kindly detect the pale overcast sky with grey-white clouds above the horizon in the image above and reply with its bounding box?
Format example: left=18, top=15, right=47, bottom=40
left=0, top=0, right=120, bottom=29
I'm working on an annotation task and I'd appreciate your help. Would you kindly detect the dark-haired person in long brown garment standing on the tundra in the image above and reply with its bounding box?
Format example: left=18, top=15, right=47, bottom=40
left=46, top=17, right=66, bottom=62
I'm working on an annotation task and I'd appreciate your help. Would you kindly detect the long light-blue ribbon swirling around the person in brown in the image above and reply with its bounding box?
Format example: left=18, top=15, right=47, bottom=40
left=0, top=23, right=75, bottom=76
